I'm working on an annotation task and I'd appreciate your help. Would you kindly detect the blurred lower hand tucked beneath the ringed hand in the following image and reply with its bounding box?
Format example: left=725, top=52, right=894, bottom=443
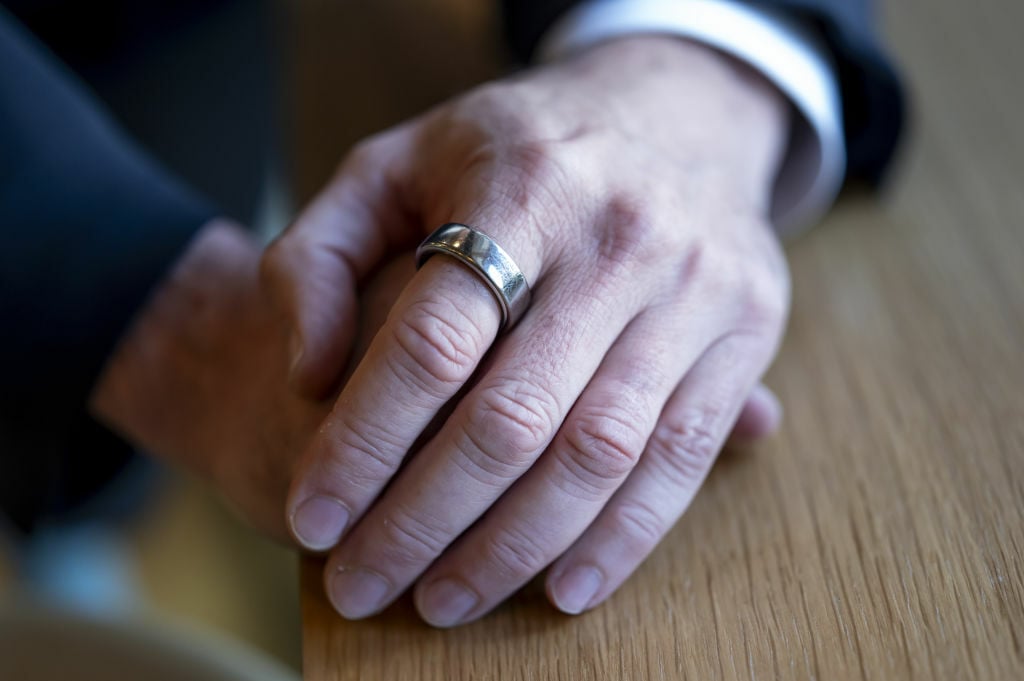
left=90, top=221, right=412, bottom=541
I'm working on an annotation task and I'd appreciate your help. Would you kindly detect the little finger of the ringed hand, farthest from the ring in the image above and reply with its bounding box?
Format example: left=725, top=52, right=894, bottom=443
left=547, top=335, right=773, bottom=613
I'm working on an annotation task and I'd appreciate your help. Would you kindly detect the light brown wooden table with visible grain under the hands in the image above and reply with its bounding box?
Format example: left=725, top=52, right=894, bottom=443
left=296, top=0, right=1024, bottom=681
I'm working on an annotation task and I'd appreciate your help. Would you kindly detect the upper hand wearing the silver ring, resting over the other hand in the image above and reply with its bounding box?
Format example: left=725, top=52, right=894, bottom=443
left=263, top=37, right=788, bottom=626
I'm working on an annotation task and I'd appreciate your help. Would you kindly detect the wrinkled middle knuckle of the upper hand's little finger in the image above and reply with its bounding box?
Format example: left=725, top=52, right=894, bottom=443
left=651, top=408, right=720, bottom=488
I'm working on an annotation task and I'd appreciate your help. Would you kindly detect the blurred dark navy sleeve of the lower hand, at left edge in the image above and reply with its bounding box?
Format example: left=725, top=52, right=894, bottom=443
left=0, top=9, right=214, bottom=525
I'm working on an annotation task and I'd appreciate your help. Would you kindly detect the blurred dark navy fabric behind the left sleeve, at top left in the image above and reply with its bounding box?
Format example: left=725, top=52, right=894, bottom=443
left=8, top=0, right=282, bottom=224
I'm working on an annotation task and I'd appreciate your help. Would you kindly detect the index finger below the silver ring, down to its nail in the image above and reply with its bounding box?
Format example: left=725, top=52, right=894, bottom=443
left=288, top=257, right=500, bottom=550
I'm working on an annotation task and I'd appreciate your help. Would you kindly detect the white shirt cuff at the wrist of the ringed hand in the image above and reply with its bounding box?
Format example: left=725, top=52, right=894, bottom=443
left=539, top=0, right=846, bottom=236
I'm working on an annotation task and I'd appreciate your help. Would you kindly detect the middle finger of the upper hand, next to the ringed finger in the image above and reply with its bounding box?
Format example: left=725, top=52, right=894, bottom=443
left=325, top=266, right=679, bottom=618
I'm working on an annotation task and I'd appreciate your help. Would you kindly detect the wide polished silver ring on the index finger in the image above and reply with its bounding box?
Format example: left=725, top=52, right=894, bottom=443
left=416, top=222, right=529, bottom=329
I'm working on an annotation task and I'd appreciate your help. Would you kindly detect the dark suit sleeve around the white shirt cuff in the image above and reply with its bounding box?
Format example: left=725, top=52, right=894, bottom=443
left=503, top=0, right=904, bottom=183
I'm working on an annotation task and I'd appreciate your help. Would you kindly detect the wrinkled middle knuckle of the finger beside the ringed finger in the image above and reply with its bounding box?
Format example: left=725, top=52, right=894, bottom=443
left=469, top=381, right=559, bottom=461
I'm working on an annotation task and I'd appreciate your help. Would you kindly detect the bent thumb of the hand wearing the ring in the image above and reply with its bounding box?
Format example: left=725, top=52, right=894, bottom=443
left=260, top=130, right=416, bottom=398
